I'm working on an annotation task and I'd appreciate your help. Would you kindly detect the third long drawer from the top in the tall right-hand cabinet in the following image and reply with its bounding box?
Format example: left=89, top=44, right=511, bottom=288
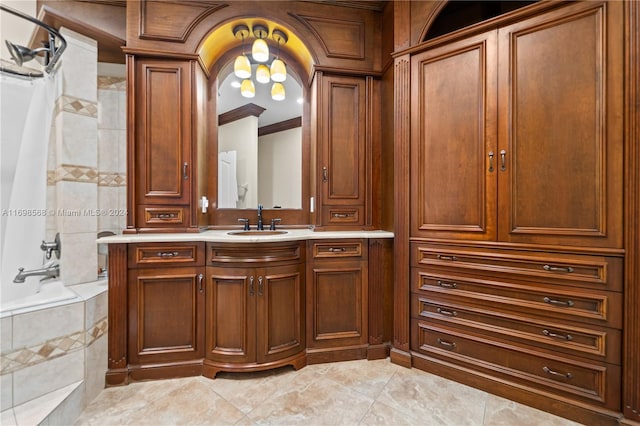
left=411, top=294, right=622, bottom=365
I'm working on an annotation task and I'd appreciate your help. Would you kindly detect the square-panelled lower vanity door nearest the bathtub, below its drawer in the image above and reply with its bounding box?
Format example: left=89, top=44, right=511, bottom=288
left=128, top=268, right=204, bottom=364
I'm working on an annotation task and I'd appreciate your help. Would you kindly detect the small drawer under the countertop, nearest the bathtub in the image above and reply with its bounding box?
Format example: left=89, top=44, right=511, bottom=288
left=129, top=242, right=204, bottom=268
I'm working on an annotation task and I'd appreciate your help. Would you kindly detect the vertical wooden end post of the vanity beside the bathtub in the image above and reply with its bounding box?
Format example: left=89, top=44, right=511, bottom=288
left=106, top=244, right=129, bottom=386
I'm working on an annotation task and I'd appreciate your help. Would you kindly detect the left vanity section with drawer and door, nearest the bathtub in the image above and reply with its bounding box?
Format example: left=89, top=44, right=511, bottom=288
left=127, top=243, right=205, bottom=380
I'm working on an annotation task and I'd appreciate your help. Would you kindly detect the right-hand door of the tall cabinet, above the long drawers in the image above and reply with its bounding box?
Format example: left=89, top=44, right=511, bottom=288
left=498, top=2, right=624, bottom=247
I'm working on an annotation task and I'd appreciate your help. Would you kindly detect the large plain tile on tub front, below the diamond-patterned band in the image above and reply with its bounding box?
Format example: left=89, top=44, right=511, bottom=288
left=13, top=349, right=84, bottom=405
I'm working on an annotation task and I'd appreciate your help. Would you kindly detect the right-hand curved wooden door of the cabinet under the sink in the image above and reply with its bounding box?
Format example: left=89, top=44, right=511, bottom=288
left=256, top=264, right=305, bottom=363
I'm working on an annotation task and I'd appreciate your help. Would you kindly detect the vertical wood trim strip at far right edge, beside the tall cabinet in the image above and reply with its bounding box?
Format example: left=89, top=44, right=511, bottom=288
left=622, top=1, right=640, bottom=421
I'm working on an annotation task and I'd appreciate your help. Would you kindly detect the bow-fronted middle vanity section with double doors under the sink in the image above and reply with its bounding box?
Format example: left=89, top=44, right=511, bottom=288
left=203, top=241, right=306, bottom=377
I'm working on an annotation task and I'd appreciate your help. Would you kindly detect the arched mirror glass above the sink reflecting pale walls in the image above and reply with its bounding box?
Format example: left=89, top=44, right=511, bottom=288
left=218, top=61, right=303, bottom=209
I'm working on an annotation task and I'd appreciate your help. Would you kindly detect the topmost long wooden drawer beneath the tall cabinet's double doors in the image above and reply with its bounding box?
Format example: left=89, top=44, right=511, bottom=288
left=411, top=243, right=622, bottom=291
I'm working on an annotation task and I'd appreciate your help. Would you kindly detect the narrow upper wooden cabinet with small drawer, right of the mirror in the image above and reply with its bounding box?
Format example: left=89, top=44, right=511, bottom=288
left=320, top=76, right=367, bottom=225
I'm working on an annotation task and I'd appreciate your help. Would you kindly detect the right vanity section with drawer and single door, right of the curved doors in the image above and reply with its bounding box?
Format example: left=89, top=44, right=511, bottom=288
left=307, top=239, right=369, bottom=363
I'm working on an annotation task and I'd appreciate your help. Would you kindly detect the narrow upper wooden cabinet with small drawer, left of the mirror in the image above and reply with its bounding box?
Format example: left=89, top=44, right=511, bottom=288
left=128, top=55, right=197, bottom=231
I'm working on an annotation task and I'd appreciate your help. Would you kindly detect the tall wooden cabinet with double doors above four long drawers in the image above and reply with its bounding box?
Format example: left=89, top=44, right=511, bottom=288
left=409, top=2, right=624, bottom=423
